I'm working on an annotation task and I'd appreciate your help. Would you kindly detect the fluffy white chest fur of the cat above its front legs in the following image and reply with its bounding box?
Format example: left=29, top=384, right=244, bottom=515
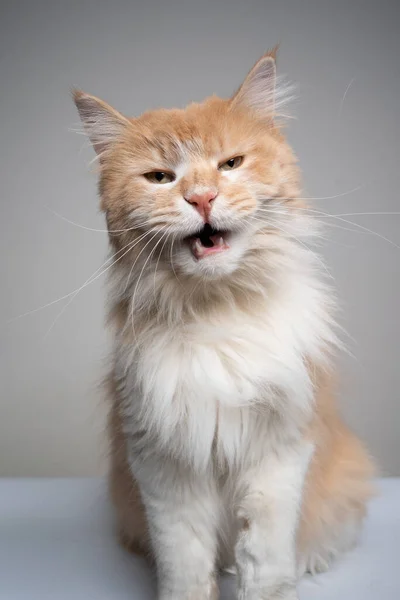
left=117, top=270, right=330, bottom=470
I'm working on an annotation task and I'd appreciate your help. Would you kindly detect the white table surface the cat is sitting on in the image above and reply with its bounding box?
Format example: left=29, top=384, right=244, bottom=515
left=0, top=479, right=400, bottom=600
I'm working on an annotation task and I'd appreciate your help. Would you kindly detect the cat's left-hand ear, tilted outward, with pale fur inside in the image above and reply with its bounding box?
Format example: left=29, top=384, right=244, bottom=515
left=72, top=90, right=130, bottom=155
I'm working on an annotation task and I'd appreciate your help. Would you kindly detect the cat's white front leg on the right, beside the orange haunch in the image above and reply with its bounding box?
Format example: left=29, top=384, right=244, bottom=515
left=235, top=442, right=312, bottom=600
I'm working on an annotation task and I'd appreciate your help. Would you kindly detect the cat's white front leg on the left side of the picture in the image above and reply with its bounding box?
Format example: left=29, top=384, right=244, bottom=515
left=137, top=463, right=219, bottom=600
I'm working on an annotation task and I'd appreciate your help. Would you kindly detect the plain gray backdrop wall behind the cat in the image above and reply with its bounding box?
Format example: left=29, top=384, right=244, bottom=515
left=0, top=0, right=400, bottom=476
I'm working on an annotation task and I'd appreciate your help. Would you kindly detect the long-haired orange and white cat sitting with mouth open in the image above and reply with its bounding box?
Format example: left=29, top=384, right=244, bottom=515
left=74, top=51, right=374, bottom=600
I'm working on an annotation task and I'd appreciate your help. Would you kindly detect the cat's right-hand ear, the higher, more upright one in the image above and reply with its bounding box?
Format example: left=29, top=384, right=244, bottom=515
left=232, top=48, right=276, bottom=118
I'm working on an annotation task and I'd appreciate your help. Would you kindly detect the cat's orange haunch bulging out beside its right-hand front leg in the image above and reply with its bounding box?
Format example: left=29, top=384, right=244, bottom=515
left=298, top=372, right=375, bottom=571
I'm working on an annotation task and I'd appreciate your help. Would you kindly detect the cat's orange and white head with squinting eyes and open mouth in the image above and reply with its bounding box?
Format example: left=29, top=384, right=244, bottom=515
left=74, top=52, right=298, bottom=279
